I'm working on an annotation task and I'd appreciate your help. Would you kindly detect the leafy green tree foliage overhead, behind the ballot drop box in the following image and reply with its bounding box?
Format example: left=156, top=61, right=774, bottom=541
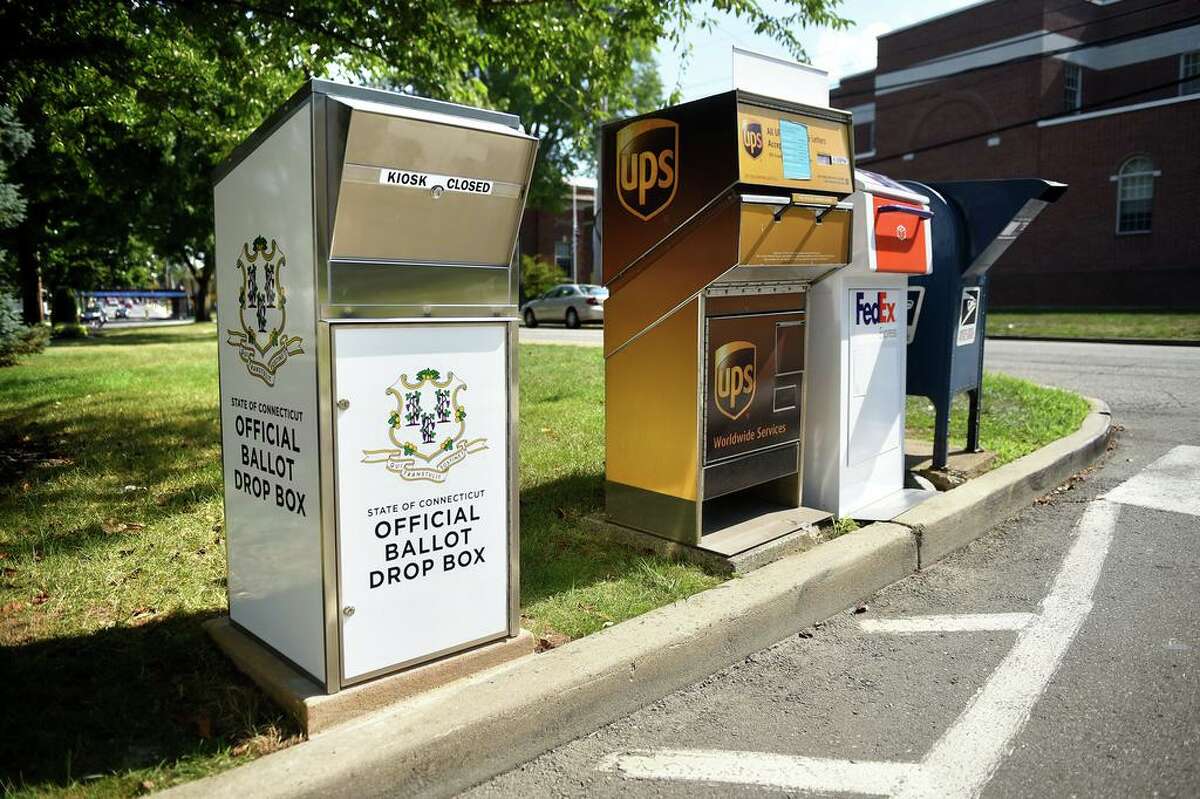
left=0, top=0, right=846, bottom=314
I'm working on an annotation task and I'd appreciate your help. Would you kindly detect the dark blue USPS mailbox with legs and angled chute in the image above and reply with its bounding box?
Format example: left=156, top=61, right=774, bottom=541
left=901, top=179, right=1067, bottom=469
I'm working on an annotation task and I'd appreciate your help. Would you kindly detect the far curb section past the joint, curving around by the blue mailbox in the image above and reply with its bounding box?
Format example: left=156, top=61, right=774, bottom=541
left=892, top=398, right=1112, bottom=567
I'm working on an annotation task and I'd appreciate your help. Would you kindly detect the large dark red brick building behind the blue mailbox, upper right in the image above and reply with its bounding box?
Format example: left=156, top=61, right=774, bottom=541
left=830, top=0, right=1200, bottom=308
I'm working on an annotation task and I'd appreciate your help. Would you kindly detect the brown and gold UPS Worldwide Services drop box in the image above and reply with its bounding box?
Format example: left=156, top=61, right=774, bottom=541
left=600, top=90, right=853, bottom=555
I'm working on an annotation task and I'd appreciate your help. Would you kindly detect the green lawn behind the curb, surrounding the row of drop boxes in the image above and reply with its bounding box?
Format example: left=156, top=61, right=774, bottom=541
left=0, top=325, right=1085, bottom=797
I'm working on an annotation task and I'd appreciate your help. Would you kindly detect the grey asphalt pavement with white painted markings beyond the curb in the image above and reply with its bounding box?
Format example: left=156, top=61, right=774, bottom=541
left=467, top=331, right=1200, bottom=798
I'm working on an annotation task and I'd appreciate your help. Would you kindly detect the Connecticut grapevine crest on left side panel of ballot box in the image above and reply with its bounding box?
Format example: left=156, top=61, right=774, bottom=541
left=226, top=235, right=304, bottom=386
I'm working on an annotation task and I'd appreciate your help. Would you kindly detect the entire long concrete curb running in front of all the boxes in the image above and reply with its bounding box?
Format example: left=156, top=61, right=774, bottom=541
left=167, top=400, right=1111, bottom=799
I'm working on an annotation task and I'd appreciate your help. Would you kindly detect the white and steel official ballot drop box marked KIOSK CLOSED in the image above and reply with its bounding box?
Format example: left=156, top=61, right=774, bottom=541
left=215, top=80, right=536, bottom=692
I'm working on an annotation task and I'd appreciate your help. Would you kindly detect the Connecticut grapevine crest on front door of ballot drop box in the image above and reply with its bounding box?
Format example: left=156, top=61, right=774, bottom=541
left=362, top=368, right=487, bottom=482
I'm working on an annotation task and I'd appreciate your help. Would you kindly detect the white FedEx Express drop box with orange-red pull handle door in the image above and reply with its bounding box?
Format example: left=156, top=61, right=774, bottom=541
left=804, top=169, right=938, bottom=519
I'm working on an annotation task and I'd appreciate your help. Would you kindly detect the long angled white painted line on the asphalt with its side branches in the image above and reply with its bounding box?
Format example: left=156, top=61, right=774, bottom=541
left=599, top=499, right=1120, bottom=799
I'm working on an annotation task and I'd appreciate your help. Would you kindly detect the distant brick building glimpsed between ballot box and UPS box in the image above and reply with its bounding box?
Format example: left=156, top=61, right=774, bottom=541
left=517, top=178, right=596, bottom=291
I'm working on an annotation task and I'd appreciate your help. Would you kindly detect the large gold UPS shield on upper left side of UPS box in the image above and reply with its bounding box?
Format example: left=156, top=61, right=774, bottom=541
left=617, top=119, right=679, bottom=222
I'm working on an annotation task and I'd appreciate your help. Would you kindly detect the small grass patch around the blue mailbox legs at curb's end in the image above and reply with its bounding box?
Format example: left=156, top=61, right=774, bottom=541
left=905, top=372, right=1090, bottom=465
